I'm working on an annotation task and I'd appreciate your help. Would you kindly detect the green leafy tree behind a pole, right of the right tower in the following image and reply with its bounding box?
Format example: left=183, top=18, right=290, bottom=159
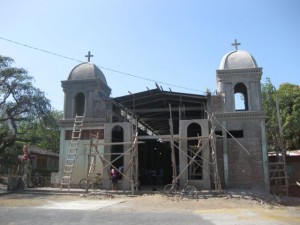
left=262, top=78, right=300, bottom=151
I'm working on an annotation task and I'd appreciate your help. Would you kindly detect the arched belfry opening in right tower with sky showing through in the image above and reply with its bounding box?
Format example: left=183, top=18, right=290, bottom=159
left=234, top=83, right=249, bottom=111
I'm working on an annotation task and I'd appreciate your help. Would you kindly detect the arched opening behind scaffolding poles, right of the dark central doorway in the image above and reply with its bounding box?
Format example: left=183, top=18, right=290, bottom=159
left=187, top=123, right=203, bottom=180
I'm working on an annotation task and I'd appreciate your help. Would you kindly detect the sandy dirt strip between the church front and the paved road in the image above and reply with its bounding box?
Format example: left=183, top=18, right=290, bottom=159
left=0, top=190, right=300, bottom=211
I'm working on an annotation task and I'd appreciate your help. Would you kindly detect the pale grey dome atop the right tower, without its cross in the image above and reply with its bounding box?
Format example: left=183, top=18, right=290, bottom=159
left=219, top=50, right=258, bottom=70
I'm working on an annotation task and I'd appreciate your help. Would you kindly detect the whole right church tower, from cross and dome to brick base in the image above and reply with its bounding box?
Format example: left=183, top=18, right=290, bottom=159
left=212, top=40, right=269, bottom=190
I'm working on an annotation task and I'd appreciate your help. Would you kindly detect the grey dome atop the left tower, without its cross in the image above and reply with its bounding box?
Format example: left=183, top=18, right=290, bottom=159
left=68, top=62, right=107, bottom=84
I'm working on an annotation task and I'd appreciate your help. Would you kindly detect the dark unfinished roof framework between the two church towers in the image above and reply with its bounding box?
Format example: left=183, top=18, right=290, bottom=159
left=114, top=88, right=207, bottom=135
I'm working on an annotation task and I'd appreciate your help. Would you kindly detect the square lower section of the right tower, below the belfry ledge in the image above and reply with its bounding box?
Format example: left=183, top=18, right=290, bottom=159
left=216, top=112, right=268, bottom=189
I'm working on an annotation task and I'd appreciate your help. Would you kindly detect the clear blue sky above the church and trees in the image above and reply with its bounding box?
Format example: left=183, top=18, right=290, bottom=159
left=0, top=0, right=300, bottom=110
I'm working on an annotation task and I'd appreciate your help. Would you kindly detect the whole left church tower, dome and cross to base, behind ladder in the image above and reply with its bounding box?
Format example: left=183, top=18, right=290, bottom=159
left=59, top=52, right=112, bottom=184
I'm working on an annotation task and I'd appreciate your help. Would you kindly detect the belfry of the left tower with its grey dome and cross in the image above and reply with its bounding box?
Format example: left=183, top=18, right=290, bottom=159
left=61, top=52, right=111, bottom=121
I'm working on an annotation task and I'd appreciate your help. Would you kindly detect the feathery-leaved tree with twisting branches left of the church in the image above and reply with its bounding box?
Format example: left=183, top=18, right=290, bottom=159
left=0, top=56, right=51, bottom=153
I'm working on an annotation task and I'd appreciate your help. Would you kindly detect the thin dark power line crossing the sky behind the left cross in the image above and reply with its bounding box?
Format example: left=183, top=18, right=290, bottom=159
left=0, top=36, right=204, bottom=92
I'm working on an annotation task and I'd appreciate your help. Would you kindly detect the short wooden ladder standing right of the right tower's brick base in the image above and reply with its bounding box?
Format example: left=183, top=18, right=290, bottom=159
left=269, top=152, right=289, bottom=196
